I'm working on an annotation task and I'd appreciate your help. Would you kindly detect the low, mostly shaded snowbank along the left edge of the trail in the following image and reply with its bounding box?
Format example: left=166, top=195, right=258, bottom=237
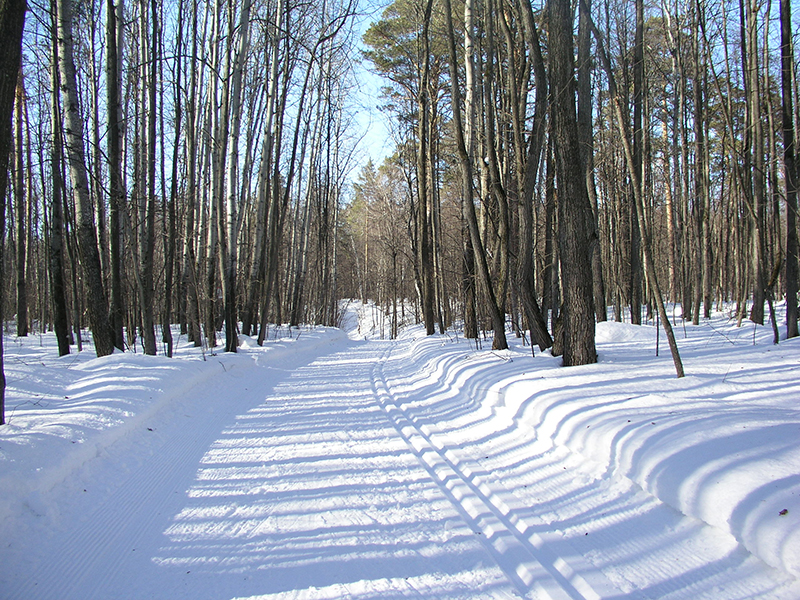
left=0, top=328, right=343, bottom=523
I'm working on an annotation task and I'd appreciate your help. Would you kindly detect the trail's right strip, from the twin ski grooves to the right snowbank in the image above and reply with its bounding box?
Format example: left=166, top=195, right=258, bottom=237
left=378, top=342, right=797, bottom=600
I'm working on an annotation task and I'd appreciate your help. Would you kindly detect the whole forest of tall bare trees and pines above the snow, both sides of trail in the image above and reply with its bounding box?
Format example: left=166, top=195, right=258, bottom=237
left=0, top=0, right=800, bottom=422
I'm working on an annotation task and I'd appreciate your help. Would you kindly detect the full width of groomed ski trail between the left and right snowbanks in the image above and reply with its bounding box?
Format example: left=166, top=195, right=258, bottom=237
left=0, top=332, right=796, bottom=600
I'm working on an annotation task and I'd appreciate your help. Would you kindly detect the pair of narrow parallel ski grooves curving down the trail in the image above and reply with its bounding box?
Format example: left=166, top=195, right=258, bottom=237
left=373, top=345, right=623, bottom=600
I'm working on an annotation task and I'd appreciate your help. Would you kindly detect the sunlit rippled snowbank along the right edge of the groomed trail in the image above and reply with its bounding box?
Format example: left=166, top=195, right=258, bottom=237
left=409, top=314, right=800, bottom=577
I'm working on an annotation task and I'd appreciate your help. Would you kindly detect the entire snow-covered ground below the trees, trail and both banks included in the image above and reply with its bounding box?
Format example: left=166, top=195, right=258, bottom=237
left=0, top=303, right=800, bottom=600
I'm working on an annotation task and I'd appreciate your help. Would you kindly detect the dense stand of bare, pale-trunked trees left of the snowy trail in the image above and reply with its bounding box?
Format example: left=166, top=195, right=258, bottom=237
left=3, top=0, right=355, bottom=366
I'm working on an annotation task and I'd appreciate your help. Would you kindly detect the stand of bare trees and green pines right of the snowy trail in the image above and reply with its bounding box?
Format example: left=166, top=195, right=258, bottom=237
left=364, top=0, right=798, bottom=360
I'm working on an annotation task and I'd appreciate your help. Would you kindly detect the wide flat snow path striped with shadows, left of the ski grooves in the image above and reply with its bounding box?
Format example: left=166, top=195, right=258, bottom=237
left=0, top=343, right=514, bottom=600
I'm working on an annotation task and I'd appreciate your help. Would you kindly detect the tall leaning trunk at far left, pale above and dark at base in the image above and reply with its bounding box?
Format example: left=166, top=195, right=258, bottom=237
left=57, top=0, right=114, bottom=356
